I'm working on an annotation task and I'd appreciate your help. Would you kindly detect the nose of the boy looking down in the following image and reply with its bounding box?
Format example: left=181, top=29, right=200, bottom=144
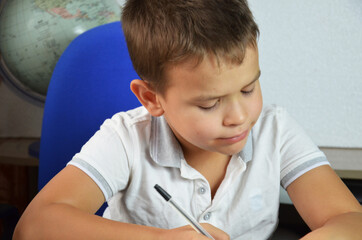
left=223, top=102, right=248, bottom=126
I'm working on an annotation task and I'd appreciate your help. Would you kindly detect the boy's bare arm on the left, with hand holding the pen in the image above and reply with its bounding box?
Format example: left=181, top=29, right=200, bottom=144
left=13, top=166, right=228, bottom=240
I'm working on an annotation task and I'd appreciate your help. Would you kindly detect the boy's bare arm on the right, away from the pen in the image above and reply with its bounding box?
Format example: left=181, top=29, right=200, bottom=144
left=287, top=165, right=362, bottom=240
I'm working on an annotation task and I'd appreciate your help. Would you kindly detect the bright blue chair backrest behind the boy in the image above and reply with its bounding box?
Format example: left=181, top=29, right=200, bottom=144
left=38, top=22, right=140, bottom=214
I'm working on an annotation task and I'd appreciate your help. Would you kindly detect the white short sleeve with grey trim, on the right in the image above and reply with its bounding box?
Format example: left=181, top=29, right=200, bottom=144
left=278, top=108, right=329, bottom=189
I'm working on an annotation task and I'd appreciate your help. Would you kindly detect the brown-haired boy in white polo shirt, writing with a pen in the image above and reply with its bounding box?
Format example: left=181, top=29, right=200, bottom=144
left=15, top=0, right=362, bottom=239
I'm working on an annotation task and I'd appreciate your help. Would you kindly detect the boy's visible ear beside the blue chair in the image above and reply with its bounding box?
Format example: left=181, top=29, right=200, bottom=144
left=131, top=79, right=164, bottom=117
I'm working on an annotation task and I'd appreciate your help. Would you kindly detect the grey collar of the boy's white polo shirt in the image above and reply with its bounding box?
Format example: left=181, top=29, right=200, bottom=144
left=150, top=116, right=253, bottom=168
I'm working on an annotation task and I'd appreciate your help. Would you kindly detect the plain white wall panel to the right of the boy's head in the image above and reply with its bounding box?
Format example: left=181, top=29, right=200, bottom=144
left=249, top=0, right=362, bottom=148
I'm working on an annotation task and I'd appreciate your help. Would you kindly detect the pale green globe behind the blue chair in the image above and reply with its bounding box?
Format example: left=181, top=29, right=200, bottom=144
left=0, top=0, right=120, bottom=104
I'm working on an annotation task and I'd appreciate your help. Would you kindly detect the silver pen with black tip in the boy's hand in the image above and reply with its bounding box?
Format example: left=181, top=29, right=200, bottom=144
left=155, top=184, right=215, bottom=240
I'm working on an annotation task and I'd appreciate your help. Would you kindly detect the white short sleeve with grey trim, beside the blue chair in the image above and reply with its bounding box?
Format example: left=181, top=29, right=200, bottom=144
left=68, top=114, right=132, bottom=200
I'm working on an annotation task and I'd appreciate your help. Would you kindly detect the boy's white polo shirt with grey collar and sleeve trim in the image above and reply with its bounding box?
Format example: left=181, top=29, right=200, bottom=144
left=69, top=106, right=329, bottom=240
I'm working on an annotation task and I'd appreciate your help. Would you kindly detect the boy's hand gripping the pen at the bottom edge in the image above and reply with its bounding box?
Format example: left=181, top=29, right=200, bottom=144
left=159, top=223, right=230, bottom=240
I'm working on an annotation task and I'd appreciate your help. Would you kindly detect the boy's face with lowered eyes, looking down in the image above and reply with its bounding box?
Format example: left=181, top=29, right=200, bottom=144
left=158, top=47, right=262, bottom=158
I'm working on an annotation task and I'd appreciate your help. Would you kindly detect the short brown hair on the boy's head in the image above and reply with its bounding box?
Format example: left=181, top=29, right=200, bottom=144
left=121, top=0, right=259, bottom=93
